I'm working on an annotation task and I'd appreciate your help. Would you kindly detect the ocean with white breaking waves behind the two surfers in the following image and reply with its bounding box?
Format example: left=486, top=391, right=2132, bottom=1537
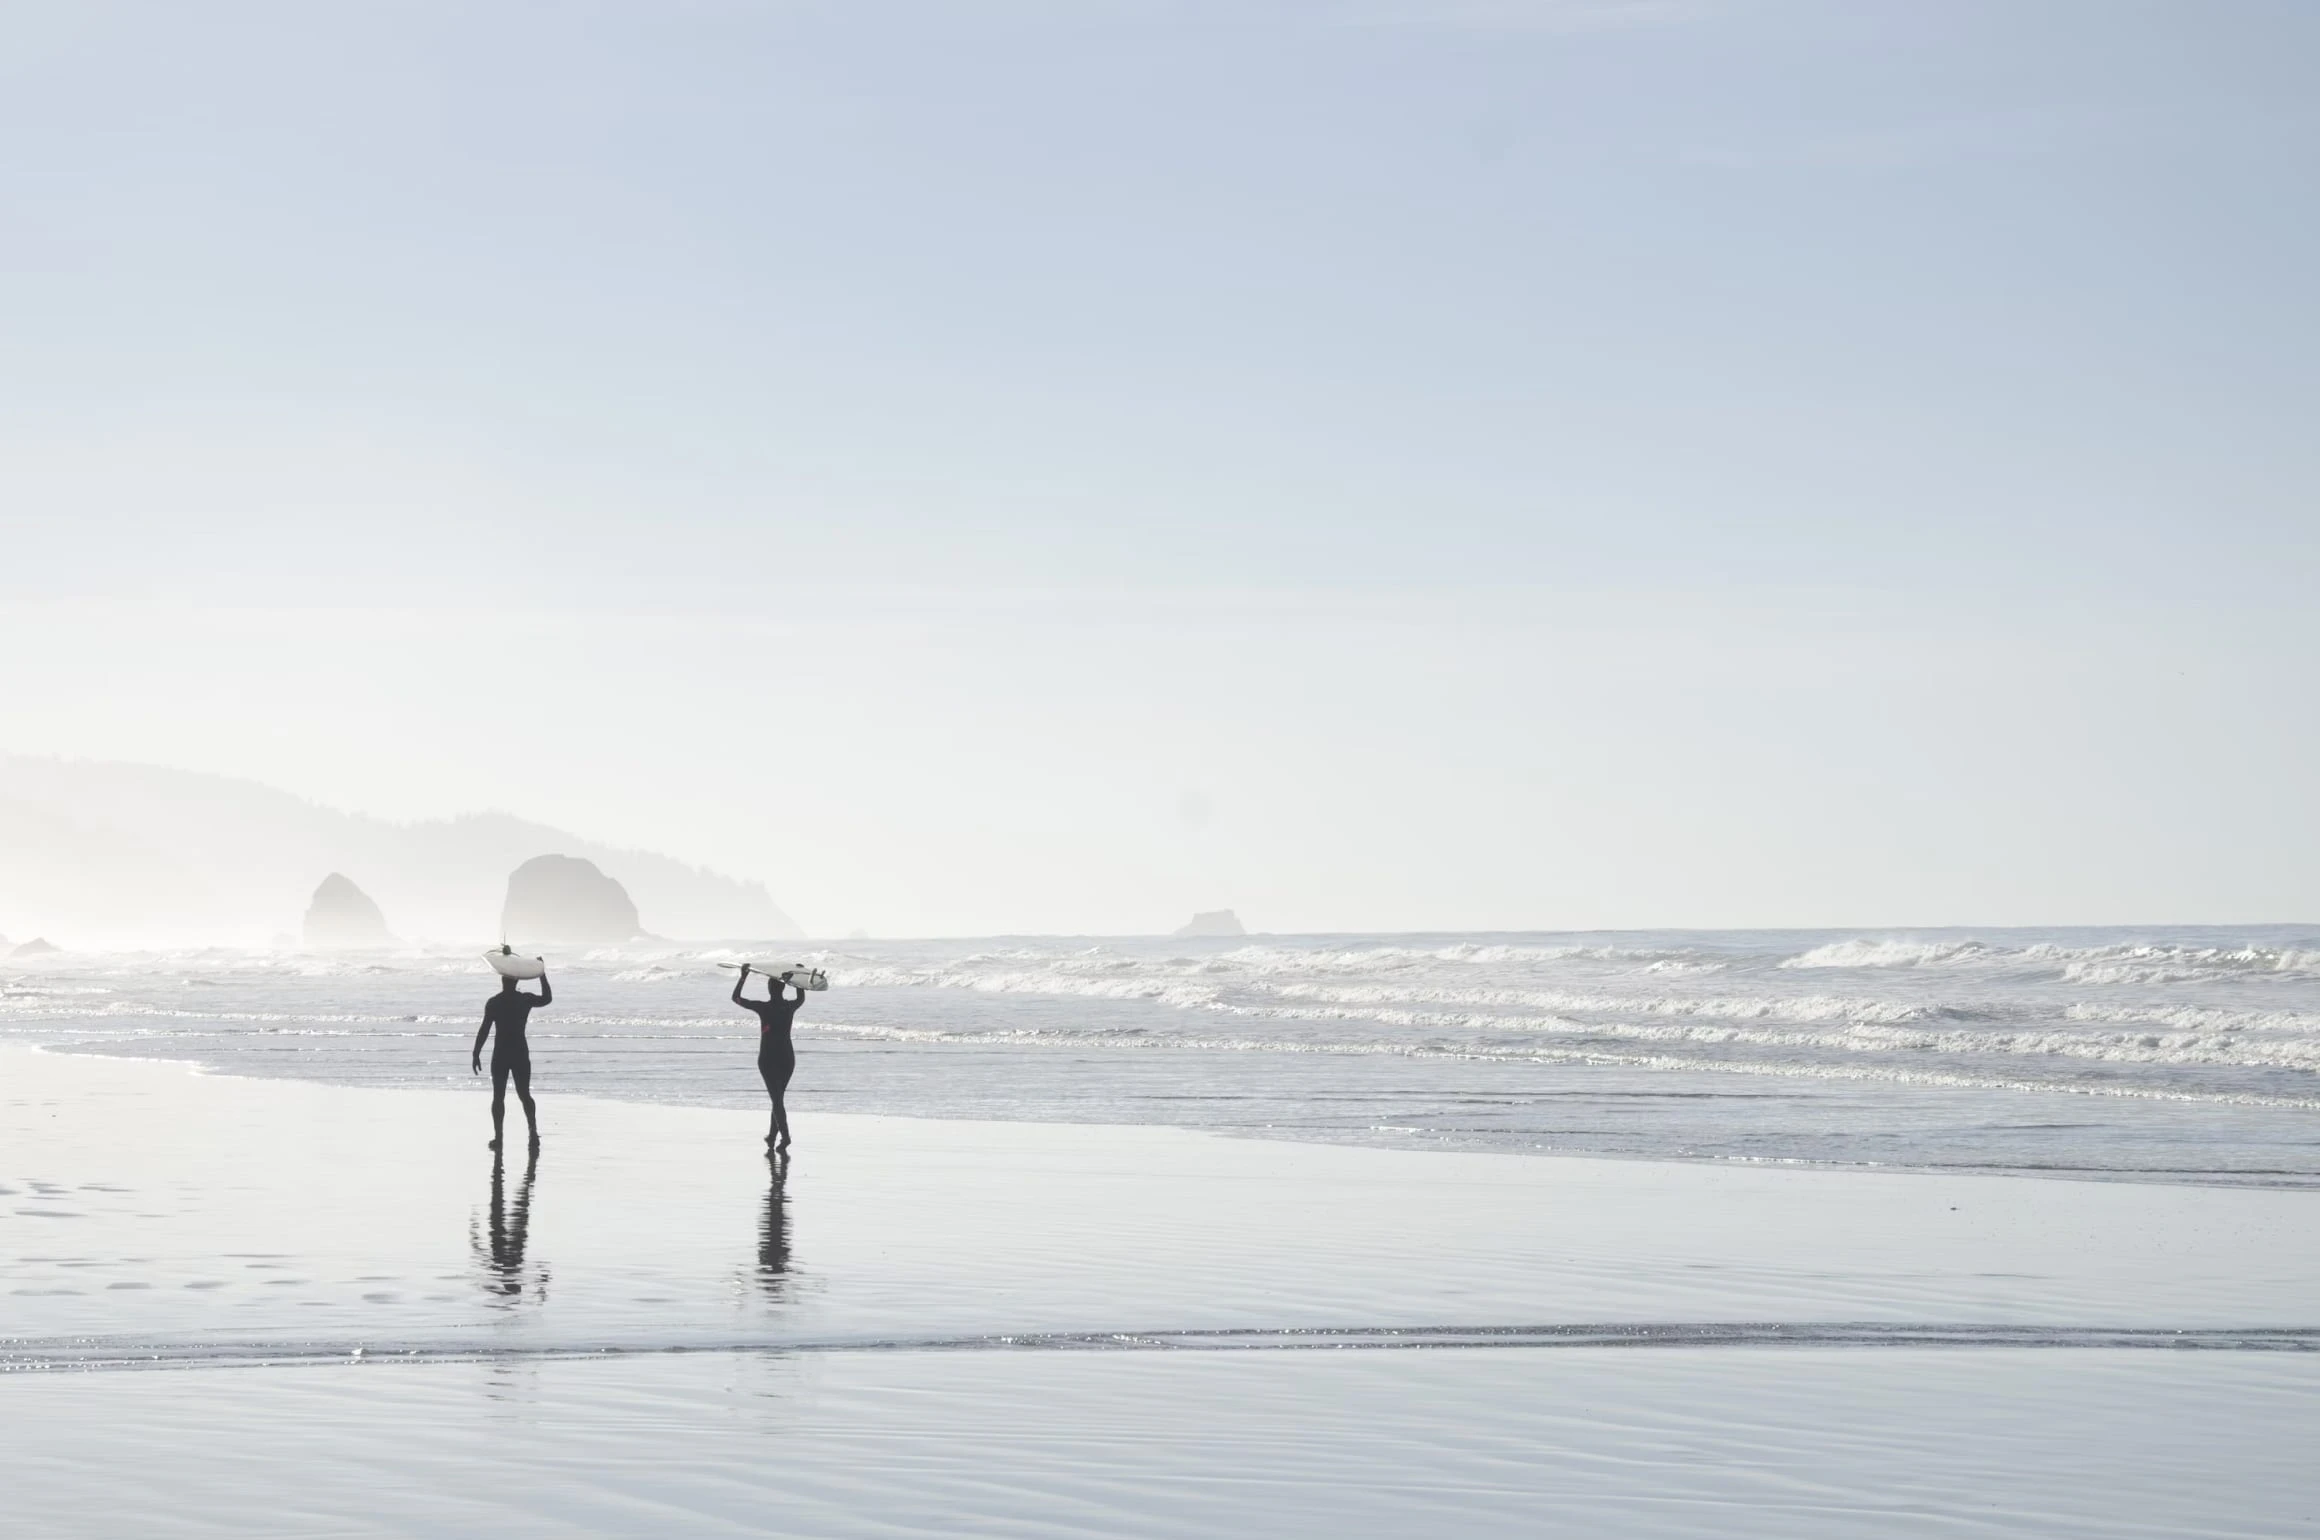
left=0, top=925, right=2320, bottom=1187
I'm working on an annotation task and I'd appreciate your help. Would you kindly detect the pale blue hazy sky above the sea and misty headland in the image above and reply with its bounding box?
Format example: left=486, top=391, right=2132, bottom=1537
left=0, top=0, right=2320, bottom=935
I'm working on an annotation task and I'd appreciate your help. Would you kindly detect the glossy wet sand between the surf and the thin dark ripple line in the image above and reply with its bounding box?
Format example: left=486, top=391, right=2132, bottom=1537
left=0, top=1048, right=2320, bottom=1368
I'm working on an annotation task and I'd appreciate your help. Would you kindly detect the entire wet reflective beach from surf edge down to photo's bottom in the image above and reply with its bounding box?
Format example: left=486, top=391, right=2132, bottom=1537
left=0, top=1046, right=2320, bottom=1535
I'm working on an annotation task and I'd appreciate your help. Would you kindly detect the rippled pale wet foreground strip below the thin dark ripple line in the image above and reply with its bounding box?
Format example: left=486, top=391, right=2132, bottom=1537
left=0, top=1348, right=2320, bottom=1540
